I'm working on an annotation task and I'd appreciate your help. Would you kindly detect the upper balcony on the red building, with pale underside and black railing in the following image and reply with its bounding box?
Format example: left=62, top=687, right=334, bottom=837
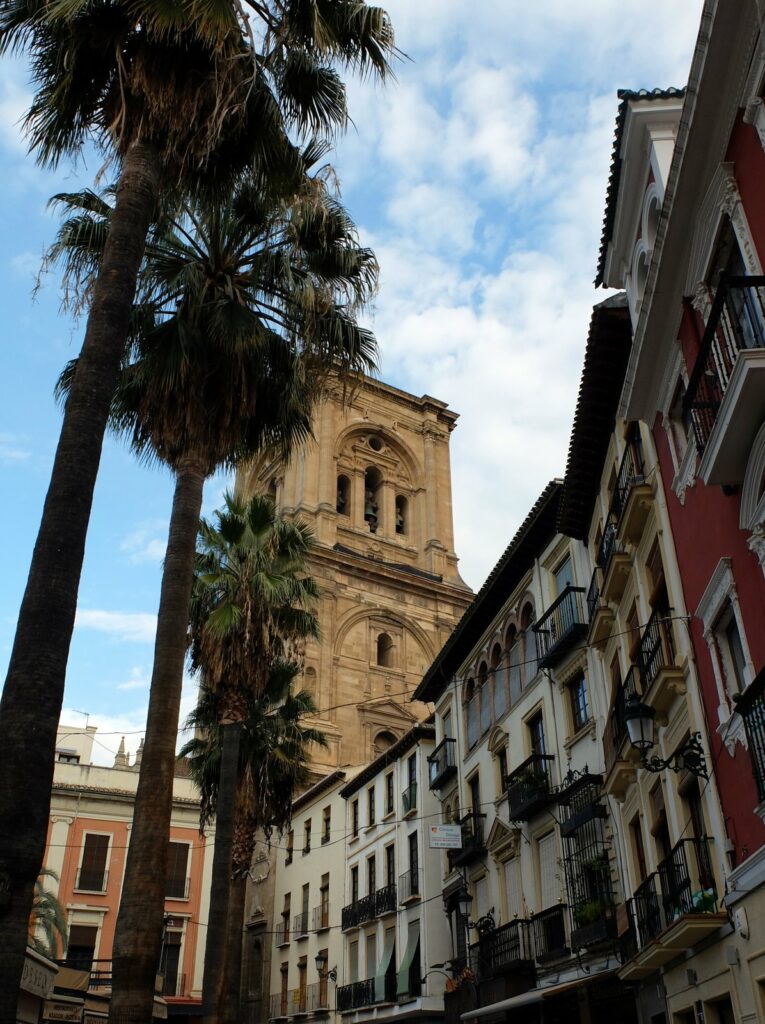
left=683, top=274, right=765, bottom=484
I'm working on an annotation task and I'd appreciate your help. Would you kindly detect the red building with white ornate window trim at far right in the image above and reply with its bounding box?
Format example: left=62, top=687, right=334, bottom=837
left=598, top=0, right=765, bottom=1022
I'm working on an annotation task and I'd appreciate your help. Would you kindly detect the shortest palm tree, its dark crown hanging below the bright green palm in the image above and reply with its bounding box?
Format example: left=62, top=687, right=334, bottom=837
left=179, top=659, right=327, bottom=1022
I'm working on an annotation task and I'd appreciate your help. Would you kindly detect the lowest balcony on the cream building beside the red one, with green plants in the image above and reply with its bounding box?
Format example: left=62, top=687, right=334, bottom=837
left=620, top=838, right=727, bottom=979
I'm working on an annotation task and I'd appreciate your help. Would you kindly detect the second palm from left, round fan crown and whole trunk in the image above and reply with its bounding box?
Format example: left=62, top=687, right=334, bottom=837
left=51, top=169, right=377, bottom=1014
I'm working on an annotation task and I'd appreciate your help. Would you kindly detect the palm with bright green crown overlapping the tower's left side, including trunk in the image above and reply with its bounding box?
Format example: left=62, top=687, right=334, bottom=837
left=190, top=495, right=318, bottom=1024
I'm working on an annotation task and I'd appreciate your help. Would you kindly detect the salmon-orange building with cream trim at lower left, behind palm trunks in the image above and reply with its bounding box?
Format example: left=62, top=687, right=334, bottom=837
left=44, top=726, right=214, bottom=1019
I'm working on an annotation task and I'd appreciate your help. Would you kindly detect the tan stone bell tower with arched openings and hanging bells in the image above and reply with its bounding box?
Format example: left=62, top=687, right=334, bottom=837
left=240, top=379, right=472, bottom=771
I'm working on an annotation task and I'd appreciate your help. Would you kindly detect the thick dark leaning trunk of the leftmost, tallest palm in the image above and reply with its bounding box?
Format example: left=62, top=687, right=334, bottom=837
left=0, top=142, right=161, bottom=1020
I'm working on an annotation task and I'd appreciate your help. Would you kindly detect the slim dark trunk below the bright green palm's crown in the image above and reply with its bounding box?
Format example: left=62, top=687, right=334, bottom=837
left=202, top=721, right=242, bottom=1024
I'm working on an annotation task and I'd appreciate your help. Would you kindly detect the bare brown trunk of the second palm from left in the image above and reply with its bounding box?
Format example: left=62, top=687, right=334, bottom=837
left=109, top=459, right=206, bottom=1024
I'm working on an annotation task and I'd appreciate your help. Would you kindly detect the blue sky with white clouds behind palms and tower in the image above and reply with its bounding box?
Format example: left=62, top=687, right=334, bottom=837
left=0, top=0, right=702, bottom=763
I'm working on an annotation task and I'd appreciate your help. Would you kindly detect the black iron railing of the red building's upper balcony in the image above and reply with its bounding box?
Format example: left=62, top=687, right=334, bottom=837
left=683, top=274, right=765, bottom=452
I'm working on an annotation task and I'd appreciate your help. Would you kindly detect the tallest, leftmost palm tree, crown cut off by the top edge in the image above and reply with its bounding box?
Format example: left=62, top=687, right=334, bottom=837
left=0, top=0, right=394, bottom=1007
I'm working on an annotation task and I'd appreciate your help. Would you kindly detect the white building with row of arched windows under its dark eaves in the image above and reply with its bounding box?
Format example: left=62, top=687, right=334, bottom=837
left=417, top=481, right=636, bottom=1022
